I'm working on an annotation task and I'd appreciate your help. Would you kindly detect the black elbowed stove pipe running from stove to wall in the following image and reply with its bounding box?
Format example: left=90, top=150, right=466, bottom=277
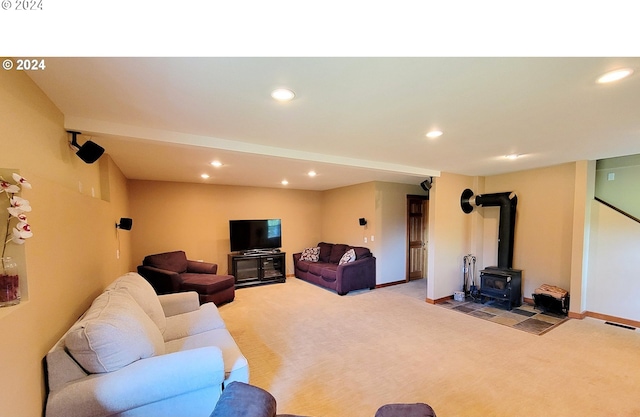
left=460, top=188, right=518, bottom=268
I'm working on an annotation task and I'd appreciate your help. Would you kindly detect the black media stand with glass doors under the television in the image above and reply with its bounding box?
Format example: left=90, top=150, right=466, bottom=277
left=227, top=251, right=287, bottom=288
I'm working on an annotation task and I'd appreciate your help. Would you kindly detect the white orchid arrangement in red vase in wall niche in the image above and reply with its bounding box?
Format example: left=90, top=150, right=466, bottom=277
left=0, top=173, right=33, bottom=307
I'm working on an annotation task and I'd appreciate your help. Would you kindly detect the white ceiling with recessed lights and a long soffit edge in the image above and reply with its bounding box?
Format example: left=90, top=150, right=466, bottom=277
left=29, top=58, right=640, bottom=190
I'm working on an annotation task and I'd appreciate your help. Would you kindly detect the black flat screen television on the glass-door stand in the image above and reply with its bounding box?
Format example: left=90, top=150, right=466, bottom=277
left=229, top=219, right=282, bottom=252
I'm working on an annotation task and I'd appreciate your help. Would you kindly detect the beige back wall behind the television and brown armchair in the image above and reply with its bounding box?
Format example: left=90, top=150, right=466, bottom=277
left=129, top=181, right=322, bottom=274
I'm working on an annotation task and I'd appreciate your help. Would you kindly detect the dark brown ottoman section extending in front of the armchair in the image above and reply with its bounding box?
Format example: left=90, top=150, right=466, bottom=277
left=180, top=273, right=236, bottom=306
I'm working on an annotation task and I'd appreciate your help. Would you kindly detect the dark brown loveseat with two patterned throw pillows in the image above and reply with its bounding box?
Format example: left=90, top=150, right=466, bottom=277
left=293, top=242, right=376, bottom=295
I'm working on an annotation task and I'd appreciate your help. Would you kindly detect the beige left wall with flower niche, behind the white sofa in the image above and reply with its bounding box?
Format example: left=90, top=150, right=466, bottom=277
left=0, top=67, right=130, bottom=417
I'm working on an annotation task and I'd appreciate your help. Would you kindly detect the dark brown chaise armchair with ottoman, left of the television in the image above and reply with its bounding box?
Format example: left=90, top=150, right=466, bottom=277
left=138, top=251, right=235, bottom=305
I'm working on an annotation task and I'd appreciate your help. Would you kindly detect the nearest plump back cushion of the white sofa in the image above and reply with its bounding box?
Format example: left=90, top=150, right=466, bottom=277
left=65, top=289, right=165, bottom=373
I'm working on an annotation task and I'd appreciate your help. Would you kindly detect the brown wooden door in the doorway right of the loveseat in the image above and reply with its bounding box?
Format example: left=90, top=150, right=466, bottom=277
left=406, top=195, right=429, bottom=281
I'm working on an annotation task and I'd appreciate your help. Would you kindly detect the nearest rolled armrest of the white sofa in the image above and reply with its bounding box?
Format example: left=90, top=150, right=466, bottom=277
left=45, top=346, right=224, bottom=417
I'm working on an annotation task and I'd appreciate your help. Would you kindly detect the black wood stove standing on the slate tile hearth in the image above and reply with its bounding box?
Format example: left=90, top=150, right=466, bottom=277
left=480, top=266, right=522, bottom=310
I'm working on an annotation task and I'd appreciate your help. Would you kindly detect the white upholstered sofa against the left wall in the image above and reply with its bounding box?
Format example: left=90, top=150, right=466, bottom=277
left=45, top=272, right=249, bottom=417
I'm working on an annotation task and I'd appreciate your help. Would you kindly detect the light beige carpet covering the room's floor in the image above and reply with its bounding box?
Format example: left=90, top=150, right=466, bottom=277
left=220, top=278, right=640, bottom=417
